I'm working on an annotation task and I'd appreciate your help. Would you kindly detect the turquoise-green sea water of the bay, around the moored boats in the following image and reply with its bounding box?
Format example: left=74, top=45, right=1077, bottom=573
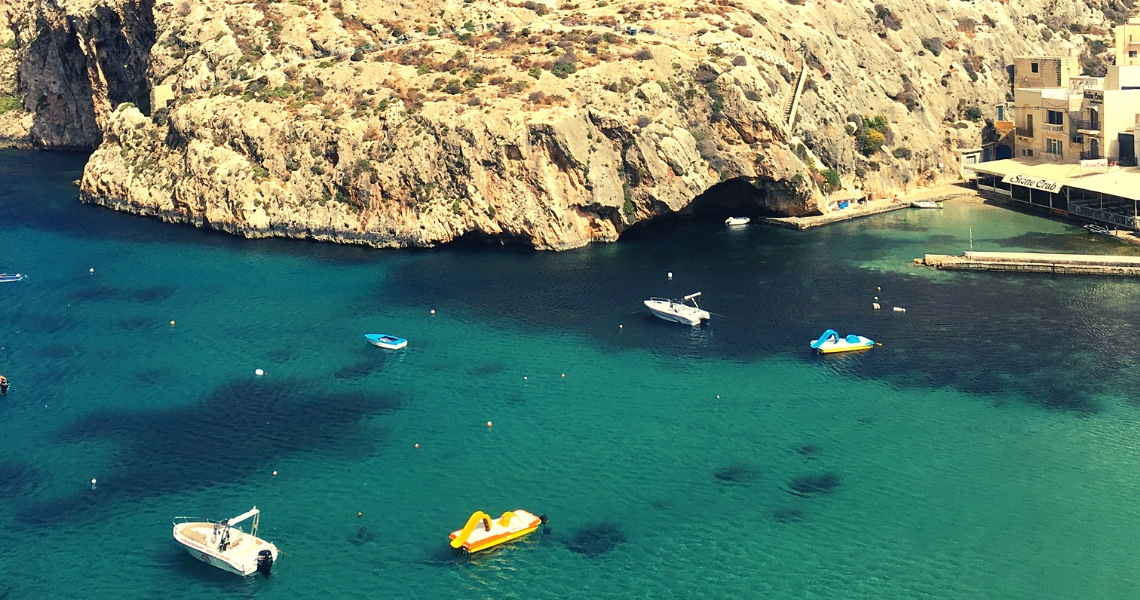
left=0, top=152, right=1140, bottom=599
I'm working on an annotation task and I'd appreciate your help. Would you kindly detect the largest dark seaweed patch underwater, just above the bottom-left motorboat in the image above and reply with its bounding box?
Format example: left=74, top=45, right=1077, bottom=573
left=22, top=379, right=402, bottom=524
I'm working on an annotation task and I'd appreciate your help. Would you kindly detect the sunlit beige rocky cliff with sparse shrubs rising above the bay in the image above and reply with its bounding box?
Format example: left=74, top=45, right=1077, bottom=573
left=0, top=0, right=1125, bottom=249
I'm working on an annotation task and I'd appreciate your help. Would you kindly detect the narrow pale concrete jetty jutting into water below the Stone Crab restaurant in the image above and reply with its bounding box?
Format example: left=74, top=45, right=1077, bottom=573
left=914, top=252, right=1140, bottom=277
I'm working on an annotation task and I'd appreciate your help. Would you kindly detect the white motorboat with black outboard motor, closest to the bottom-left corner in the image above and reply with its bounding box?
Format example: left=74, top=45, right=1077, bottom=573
left=174, top=506, right=277, bottom=577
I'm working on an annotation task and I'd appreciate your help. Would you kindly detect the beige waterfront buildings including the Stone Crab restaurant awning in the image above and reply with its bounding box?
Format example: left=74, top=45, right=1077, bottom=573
left=975, top=28, right=1140, bottom=230
